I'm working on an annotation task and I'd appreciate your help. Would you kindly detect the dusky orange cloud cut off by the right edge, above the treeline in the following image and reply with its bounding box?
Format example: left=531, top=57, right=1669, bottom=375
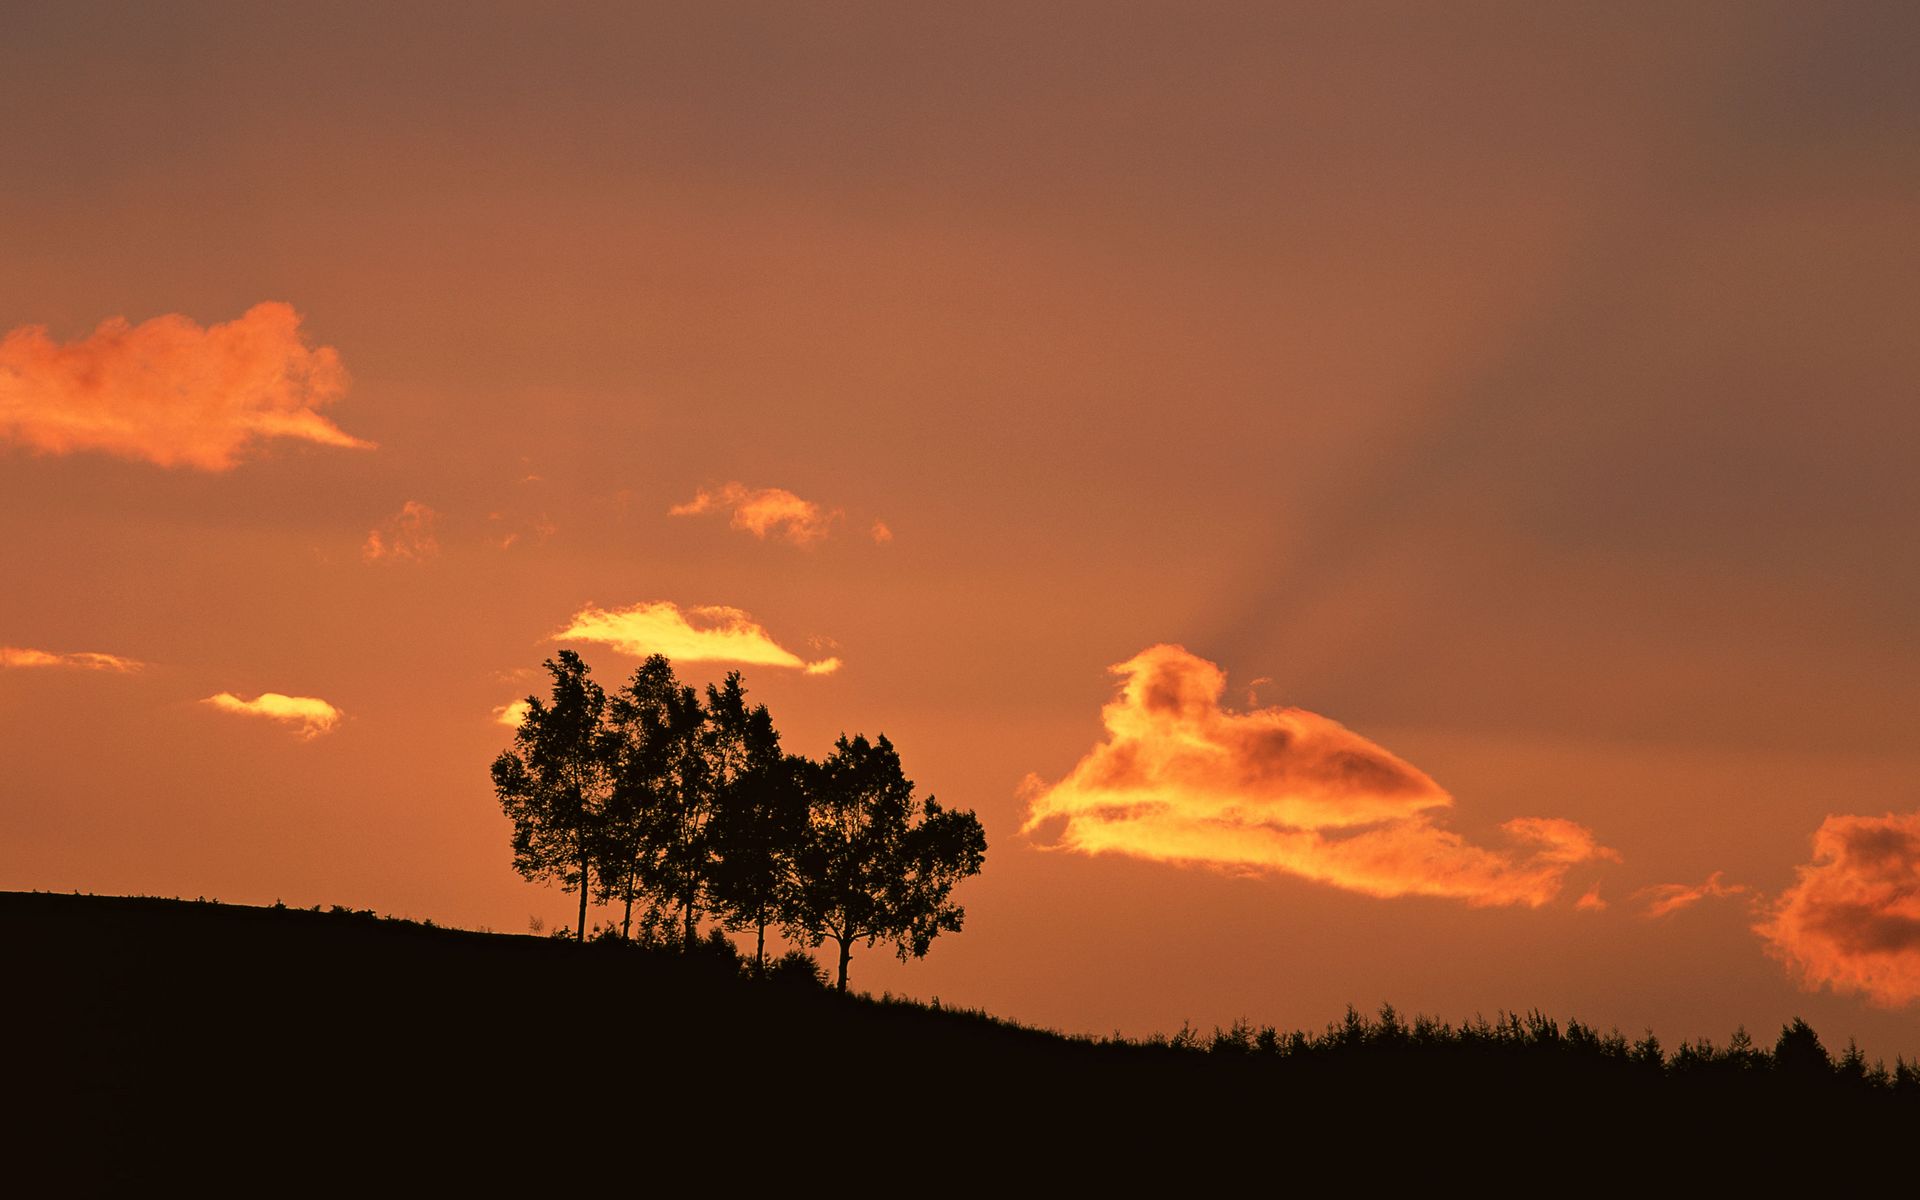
left=1753, top=812, right=1920, bottom=1008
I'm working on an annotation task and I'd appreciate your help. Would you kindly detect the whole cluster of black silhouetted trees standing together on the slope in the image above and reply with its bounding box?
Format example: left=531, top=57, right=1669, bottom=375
left=493, top=651, right=987, bottom=991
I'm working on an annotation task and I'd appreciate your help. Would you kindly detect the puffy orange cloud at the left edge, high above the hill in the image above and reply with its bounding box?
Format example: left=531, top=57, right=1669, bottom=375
left=0, top=303, right=372, bottom=470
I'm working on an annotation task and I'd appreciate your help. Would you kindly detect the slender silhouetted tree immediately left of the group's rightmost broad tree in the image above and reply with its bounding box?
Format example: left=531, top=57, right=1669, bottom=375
left=707, top=674, right=806, bottom=975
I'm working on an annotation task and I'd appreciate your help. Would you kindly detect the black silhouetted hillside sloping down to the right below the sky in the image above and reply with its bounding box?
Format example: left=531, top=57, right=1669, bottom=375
left=0, top=893, right=1920, bottom=1198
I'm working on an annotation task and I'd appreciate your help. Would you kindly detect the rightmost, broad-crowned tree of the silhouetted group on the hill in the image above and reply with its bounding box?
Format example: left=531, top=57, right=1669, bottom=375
left=785, top=735, right=987, bottom=991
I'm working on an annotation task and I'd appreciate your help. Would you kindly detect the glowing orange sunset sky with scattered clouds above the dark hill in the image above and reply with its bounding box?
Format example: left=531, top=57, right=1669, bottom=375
left=0, top=2, right=1920, bottom=1060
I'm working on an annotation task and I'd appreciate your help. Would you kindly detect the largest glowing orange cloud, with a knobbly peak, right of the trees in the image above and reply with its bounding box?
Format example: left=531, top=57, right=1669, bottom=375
left=1023, top=645, right=1617, bottom=906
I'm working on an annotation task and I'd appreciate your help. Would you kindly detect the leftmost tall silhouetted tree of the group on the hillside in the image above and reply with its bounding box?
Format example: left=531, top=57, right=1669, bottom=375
left=493, top=651, right=612, bottom=941
